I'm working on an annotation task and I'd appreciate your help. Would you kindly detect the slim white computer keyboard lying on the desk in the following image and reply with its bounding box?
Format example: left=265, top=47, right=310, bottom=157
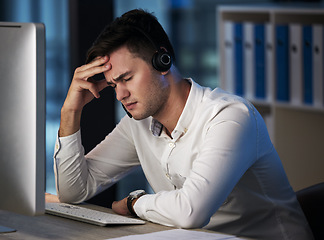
left=45, top=203, right=145, bottom=226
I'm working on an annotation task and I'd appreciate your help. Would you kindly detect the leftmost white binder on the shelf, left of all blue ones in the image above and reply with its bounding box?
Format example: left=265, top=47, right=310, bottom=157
left=223, top=21, right=235, bottom=93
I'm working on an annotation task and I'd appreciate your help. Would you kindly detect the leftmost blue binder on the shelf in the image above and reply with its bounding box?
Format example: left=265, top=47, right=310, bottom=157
left=234, top=22, right=244, bottom=96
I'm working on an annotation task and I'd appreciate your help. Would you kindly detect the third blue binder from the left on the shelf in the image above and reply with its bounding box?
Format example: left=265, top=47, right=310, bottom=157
left=275, top=24, right=290, bottom=102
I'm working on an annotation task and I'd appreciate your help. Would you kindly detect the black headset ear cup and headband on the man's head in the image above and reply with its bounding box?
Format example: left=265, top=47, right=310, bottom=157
left=132, top=26, right=172, bottom=72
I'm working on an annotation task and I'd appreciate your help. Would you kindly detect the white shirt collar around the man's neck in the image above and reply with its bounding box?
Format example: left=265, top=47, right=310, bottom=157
left=150, top=78, right=203, bottom=139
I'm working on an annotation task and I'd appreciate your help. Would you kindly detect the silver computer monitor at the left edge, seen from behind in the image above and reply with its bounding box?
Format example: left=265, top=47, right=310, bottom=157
left=0, top=22, right=46, bottom=232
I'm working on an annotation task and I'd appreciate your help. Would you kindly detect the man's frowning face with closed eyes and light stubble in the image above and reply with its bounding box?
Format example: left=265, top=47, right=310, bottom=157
left=104, top=47, right=170, bottom=120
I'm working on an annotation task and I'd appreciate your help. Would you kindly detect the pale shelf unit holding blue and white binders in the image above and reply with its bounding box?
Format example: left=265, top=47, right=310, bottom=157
left=217, top=5, right=324, bottom=190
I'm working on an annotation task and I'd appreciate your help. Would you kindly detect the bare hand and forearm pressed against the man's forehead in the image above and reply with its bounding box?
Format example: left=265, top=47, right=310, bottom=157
left=59, top=56, right=111, bottom=137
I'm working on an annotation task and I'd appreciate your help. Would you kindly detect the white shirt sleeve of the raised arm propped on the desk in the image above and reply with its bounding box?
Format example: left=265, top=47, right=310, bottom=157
left=54, top=116, right=140, bottom=203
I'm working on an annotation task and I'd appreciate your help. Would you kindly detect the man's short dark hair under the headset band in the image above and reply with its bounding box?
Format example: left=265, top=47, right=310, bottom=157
left=86, top=9, right=175, bottom=66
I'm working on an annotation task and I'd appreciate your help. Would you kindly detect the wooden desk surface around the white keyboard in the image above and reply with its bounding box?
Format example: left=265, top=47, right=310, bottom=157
left=0, top=205, right=173, bottom=240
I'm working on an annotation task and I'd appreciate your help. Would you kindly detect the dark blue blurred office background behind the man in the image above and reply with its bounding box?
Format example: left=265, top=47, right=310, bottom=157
left=0, top=0, right=322, bottom=205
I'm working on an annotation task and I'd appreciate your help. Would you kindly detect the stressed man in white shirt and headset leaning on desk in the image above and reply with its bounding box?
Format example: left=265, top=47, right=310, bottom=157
left=54, top=10, right=312, bottom=240
